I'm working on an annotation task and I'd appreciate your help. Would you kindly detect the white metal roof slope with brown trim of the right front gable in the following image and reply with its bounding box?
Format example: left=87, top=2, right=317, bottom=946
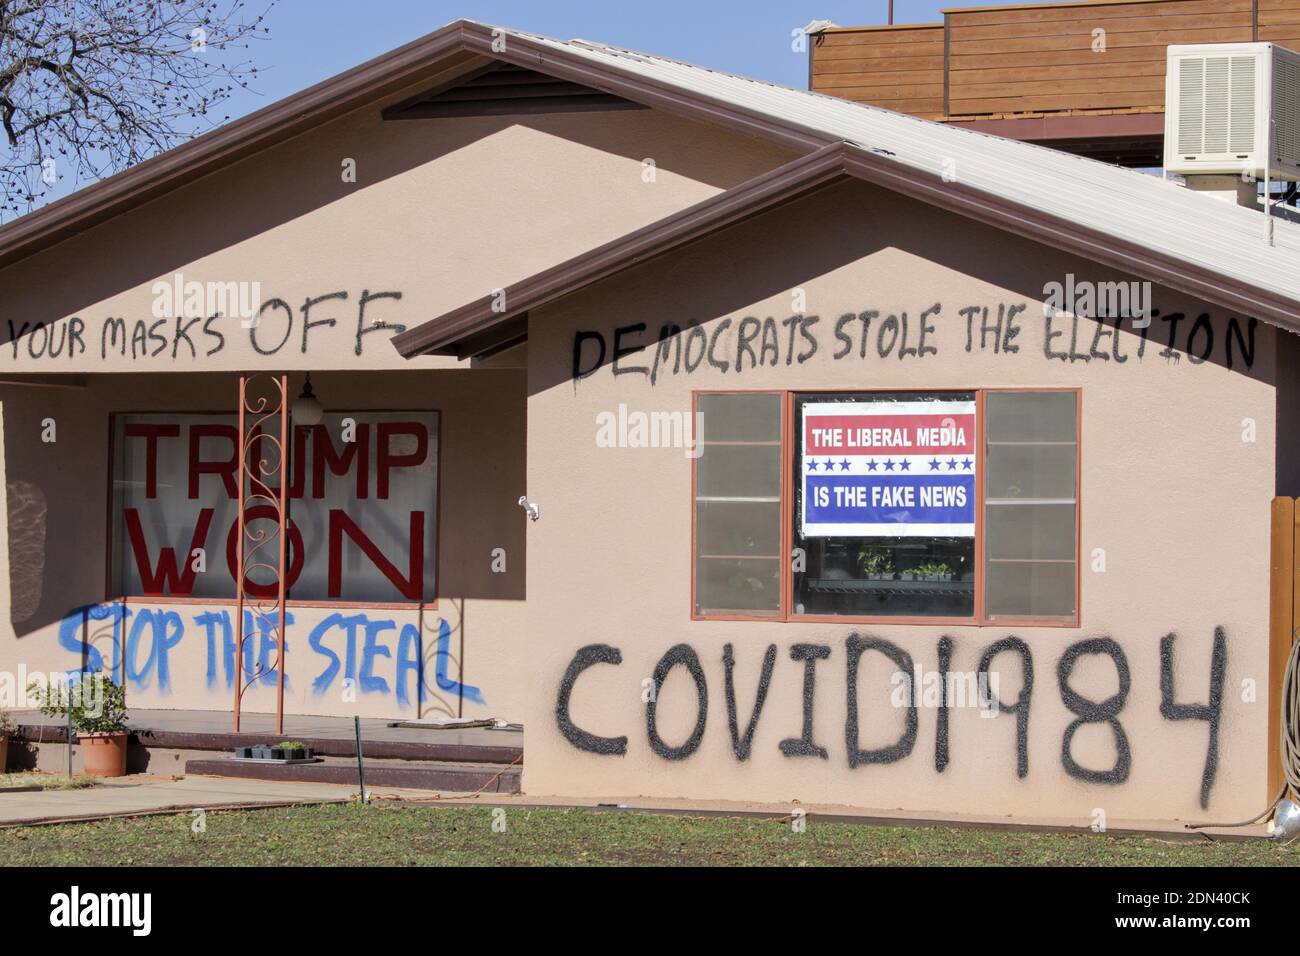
left=393, top=23, right=1300, bottom=356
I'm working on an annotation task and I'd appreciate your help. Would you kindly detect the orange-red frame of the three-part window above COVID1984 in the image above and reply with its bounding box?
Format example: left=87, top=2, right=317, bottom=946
left=689, top=385, right=1083, bottom=628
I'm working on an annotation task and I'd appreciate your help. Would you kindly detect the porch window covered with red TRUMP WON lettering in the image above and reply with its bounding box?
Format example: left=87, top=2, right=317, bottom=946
left=109, top=411, right=438, bottom=604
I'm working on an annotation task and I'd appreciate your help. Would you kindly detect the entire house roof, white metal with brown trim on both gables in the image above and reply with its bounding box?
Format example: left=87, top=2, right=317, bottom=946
left=0, top=20, right=1300, bottom=345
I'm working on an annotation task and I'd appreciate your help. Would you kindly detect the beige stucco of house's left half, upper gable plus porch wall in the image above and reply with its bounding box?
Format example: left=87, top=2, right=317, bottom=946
left=0, top=100, right=789, bottom=719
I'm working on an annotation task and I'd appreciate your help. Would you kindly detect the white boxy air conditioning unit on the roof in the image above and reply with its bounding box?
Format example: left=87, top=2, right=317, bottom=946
left=1165, top=43, right=1300, bottom=179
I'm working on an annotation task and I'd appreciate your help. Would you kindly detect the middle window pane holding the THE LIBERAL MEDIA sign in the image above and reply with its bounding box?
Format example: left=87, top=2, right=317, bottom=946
left=792, top=392, right=978, bottom=618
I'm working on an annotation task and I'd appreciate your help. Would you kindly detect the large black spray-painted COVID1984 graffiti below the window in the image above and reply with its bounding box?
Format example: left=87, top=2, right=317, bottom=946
left=555, top=627, right=1227, bottom=808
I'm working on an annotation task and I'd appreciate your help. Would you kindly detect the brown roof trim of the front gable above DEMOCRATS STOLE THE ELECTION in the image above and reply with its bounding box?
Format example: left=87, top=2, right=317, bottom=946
left=391, top=142, right=1300, bottom=358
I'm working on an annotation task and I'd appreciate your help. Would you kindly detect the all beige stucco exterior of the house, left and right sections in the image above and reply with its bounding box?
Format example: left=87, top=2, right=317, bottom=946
left=0, top=82, right=1294, bottom=822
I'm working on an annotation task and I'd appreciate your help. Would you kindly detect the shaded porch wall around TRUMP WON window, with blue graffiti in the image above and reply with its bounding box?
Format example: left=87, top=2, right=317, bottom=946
left=0, top=369, right=527, bottom=719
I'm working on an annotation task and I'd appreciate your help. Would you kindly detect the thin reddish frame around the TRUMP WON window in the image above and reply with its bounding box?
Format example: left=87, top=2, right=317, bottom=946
left=104, top=408, right=446, bottom=611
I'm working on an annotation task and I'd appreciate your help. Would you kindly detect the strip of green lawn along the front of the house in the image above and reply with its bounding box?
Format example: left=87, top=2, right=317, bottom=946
left=0, top=804, right=1284, bottom=866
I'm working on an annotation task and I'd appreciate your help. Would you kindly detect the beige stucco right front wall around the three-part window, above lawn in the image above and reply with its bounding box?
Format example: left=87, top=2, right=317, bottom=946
left=524, top=185, right=1275, bottom=825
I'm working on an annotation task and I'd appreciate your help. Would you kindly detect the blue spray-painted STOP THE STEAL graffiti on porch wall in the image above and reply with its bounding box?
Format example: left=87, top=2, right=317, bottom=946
left=59, top=604, right=486, bottom=708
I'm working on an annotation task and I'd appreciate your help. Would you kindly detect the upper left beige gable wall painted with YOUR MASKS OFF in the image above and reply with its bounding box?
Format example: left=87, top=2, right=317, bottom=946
left=0, top=95, right=789, bottom=375
